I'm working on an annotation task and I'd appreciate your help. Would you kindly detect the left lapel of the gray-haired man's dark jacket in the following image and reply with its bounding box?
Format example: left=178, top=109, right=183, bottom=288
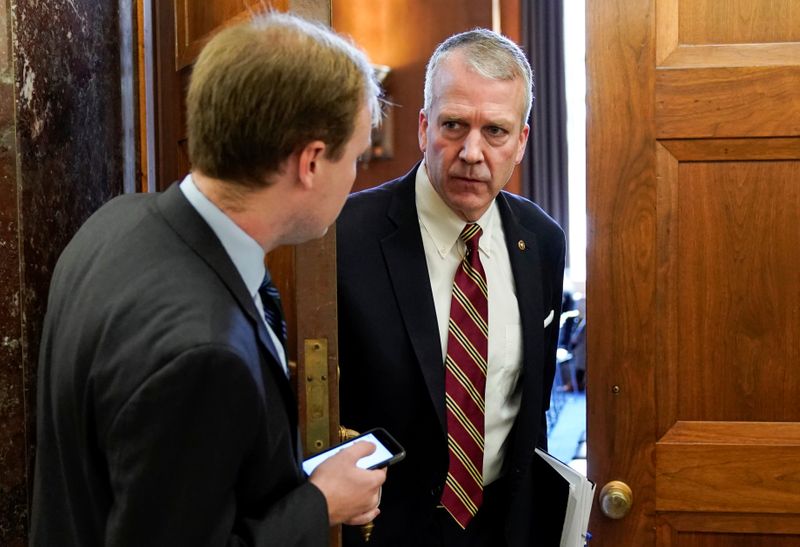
left=381, top=169, right=446, bottom=431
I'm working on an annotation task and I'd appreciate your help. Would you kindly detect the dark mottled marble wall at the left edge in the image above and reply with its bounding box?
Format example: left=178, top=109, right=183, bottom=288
left=0, top=0, right=124, bottom=546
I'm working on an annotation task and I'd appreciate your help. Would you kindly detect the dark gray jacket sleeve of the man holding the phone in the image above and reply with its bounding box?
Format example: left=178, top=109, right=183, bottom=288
left=104, top=346, right=329, bottom=547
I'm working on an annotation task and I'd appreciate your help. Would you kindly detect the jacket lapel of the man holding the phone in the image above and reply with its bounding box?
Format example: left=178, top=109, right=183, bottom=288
left=153, top=183, right=297, bottom=427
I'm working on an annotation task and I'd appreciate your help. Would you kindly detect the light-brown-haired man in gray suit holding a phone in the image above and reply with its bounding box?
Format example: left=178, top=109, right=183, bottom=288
left=30, top=13, right=386, bottom=547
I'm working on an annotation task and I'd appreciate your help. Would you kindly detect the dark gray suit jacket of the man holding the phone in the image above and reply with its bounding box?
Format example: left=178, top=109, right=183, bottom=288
left=31, top=184, right=328, bottom=547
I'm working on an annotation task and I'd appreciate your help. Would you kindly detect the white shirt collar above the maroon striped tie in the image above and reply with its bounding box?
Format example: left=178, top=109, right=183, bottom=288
left=414, top=161, right=497, bottom=257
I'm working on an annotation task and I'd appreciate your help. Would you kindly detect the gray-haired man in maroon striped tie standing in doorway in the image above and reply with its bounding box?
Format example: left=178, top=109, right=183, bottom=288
left=337, top=29, right=565, bottom=547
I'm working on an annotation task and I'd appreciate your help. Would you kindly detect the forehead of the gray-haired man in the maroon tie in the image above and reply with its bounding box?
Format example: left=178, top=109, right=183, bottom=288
left=431, top=53, right=525, bottom=123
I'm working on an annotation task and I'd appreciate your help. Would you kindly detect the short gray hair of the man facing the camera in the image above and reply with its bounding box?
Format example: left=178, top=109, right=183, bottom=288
left=423, top=28, right=533, bottom=125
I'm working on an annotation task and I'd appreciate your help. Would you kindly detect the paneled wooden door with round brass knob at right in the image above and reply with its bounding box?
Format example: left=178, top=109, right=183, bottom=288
left=587, top=0, right=800, bottom=547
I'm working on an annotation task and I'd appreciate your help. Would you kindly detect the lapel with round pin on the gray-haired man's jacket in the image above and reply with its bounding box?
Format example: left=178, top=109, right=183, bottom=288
left=497, top=193, right=545, bottom=478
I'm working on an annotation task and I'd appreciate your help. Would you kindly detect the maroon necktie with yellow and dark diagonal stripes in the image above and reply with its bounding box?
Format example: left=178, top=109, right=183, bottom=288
left=442, top=220, right=489, bottom=528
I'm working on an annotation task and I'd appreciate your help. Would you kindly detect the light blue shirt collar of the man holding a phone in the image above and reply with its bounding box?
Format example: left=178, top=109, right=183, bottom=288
left=180, top=174, right=267, bottom=298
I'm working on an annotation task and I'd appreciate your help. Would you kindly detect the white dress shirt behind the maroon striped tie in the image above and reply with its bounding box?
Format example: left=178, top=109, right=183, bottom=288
left=415, top=163, right=522, bottom=485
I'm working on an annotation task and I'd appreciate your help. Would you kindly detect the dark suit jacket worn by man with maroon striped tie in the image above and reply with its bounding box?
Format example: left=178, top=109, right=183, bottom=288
left=337, top=168, right=565, bottom=547
